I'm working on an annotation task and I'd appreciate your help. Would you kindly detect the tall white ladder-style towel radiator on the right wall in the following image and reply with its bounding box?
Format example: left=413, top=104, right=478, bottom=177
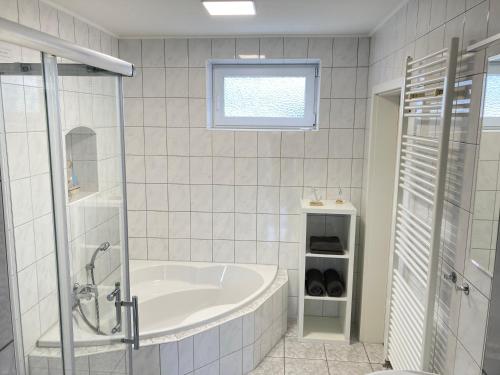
left=385, top=38, right=458, bottom=370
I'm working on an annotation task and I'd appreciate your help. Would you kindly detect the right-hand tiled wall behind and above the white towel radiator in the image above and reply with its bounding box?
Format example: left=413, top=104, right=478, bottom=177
left=369, top=0, right=500, bottom=375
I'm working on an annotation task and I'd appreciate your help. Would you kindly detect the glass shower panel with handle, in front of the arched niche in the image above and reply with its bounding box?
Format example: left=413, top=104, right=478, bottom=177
left=58, top=60, right=129, bottom=352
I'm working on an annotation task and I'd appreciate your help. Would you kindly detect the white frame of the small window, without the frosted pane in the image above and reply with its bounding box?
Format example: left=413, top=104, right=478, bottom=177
left=206, top=59, right=321, bottom=131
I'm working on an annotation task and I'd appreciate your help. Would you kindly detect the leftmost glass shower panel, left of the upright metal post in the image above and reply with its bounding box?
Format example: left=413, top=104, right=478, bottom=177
left=0, top=42, right=61, bottom=373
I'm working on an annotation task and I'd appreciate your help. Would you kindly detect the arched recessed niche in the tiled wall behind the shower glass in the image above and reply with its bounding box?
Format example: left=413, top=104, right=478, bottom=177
left=65, top=126, right=99, bottom=202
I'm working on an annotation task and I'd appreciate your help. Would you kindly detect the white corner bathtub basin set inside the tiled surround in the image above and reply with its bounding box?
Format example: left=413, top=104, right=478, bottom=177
left=38, top=260, right=277, bottom=347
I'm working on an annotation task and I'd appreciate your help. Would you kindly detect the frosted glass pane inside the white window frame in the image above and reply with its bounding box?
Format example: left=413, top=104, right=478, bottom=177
left=224, top=77, right=306, bottom=118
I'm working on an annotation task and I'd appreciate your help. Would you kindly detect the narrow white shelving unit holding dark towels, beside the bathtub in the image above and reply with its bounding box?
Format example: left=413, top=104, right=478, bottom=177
left=298, top=200, right=356, bottom=342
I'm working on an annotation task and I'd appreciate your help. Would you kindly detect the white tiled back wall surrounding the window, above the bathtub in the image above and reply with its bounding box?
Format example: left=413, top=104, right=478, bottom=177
left=119, top=37, right=369, bottom=317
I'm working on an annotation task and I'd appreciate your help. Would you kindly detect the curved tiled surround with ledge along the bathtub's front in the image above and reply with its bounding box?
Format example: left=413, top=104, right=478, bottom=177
left=29, top=270, right=288, bottom=375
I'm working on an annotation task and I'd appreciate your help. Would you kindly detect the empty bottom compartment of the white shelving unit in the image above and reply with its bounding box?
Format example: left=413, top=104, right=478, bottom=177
left=303, top=315, right=346, bottom=341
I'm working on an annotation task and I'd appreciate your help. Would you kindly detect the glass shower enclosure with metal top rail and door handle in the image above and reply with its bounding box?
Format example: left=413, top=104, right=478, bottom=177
left=0, top=18, right=138, bottom=374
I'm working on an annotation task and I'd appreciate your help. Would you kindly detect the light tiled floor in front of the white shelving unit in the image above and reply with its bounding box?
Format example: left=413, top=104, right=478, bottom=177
left=251, top=323, right=384, bottom=375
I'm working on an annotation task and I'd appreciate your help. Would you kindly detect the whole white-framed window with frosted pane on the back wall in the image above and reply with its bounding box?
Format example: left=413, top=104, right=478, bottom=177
left=207, top=59, right=320, bottom=130
